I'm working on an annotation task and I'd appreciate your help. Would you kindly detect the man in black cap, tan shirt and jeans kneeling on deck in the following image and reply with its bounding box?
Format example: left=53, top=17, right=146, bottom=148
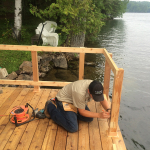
left=44, top=80, right=110, bottom=132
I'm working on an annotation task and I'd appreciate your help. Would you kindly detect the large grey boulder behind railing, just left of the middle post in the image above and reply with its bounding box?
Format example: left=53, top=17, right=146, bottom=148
left=53, top=55, right=68, bottom=69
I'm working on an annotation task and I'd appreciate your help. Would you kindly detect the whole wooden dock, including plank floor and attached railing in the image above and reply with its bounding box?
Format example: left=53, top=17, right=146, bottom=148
left=0, top=45, right=126, bottom=150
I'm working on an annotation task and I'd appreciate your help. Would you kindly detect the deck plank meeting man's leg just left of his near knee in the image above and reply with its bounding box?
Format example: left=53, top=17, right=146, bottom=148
left=54, top=126, right=67, bottom=150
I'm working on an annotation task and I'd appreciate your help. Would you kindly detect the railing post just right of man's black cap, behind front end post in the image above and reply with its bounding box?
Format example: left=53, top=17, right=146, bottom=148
left=104, top=53, right=112, bottom=99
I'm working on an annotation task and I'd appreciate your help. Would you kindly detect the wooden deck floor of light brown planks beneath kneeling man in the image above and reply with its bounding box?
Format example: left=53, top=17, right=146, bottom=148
left=0, top=87, right=126, bottom=150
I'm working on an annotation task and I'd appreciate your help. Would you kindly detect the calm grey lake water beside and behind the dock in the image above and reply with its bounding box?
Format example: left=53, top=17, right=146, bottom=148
left=44, top=13, right=150, bottom=150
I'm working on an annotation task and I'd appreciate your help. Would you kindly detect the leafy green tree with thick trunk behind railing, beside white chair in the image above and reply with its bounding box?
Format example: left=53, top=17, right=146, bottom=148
left=30, top=0, right=103, bottom=47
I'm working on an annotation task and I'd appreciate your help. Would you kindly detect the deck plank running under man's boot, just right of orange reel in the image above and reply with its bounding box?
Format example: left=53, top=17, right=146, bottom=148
left=29, top=89, right=51, bottom=150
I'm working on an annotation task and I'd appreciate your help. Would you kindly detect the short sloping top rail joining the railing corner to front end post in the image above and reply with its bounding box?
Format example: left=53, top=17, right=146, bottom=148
left=103, top=49, right=118, bottom=75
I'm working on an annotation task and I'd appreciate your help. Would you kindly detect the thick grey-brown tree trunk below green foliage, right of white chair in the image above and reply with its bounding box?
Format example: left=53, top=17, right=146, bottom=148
left=70, top=32, right=85, bottom=47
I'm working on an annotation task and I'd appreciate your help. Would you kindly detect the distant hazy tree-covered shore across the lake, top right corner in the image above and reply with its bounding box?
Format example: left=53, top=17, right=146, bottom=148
left=126, top=1, right=150, bottom=13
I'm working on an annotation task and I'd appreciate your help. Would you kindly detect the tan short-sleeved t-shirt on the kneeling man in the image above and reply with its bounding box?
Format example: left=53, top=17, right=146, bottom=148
left=56, top=80, right=92, bottom=109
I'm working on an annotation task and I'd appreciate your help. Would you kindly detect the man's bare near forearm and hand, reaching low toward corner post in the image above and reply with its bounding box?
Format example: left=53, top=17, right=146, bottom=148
left=78, top=108, right=110, bottom=119
